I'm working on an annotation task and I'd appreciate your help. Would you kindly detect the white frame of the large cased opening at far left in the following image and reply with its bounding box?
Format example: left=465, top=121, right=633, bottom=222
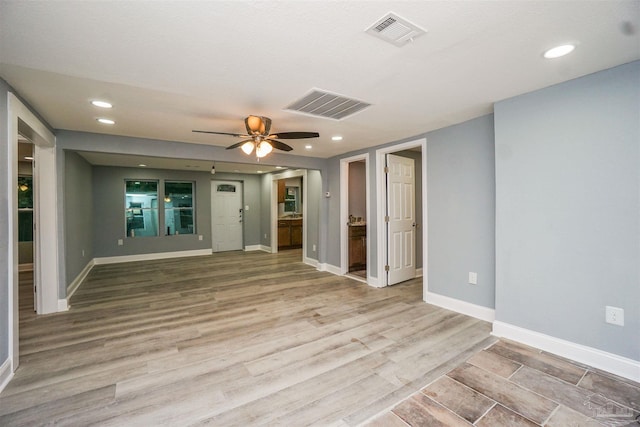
left=7, top=92, right=58, bottom=372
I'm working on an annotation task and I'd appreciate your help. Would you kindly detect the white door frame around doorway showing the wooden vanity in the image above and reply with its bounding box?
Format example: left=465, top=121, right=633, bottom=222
left=340, top=153, right=371, bottom=283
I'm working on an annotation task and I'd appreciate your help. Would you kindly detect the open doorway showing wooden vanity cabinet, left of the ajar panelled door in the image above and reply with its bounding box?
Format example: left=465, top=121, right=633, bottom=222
left=340, top=154, right=371, bottom=283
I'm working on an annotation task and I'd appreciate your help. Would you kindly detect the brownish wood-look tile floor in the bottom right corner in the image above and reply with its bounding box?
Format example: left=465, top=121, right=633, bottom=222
left=367, top=340, right=640, bottom=427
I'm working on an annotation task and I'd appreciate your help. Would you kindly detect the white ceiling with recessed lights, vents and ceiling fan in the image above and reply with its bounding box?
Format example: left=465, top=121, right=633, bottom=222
left=0, top=0, right=640, bottom=158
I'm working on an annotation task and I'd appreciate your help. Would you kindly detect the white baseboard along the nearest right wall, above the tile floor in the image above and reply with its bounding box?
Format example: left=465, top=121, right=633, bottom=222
left=492, top=321, right=640, bottom=382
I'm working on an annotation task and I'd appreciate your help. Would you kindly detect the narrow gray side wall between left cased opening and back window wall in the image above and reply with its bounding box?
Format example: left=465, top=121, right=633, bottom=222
left=64, top=151, right=95, bottom=295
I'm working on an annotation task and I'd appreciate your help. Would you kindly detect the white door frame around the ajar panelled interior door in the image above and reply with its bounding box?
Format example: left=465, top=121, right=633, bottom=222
left=376, top=138, right=429, bottom=292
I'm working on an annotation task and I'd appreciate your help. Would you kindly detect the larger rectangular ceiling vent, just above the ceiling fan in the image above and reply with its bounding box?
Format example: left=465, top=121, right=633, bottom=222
left=285, top=89, right=371, bottom=120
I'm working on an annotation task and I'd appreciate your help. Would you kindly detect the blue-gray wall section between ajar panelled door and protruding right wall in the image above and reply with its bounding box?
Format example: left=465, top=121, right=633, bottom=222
left=427, top=115, right=495, bottom=308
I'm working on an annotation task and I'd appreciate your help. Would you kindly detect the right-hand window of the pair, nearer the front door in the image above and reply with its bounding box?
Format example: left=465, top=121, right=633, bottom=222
left=164, top=181, right=195, bottom=236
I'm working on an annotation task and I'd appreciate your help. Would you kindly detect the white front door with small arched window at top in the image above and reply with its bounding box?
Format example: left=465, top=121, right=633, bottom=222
left=211, top=181, right=244, bottom=252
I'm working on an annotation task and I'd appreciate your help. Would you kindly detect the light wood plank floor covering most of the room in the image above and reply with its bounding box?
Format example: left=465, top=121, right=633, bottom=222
left=0, top=251, right=495, bottom=426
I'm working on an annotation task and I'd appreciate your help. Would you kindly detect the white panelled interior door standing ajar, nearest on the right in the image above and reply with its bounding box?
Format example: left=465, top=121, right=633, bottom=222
left=387, top=154, right=416, bottom=285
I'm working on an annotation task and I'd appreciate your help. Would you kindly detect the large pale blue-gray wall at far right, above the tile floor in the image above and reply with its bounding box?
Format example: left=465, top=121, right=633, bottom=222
left=495, top=62, right=640, bottom=360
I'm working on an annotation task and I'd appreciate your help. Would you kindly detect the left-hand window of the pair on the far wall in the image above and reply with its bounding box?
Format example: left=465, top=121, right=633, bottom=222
left=124, top=180, right=158, bottom=237
